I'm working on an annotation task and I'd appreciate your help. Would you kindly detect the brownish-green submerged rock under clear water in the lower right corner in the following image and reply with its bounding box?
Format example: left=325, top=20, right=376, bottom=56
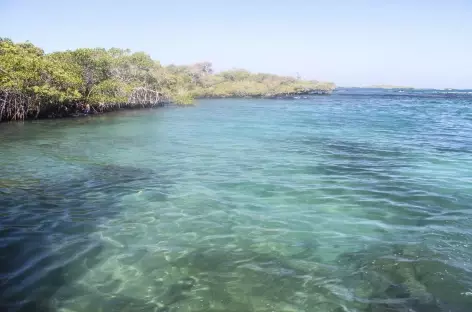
left=339, top=245, right=472, bottom=312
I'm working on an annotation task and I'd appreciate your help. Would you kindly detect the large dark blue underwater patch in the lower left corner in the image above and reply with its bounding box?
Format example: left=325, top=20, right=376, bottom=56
left=0, top=161, right=173, bottom=312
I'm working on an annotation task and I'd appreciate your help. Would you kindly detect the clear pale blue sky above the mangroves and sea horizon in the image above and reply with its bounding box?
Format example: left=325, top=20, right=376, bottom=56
left=0, top=0, right=472, bottom=88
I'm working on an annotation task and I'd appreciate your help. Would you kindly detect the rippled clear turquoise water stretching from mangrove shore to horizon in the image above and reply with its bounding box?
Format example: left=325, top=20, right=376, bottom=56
left=0, top=90, right=472, bottom=312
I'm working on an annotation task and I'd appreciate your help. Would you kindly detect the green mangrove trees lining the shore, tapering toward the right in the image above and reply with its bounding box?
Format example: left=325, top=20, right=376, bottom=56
left=0, top=38, right=335, bottom=121
